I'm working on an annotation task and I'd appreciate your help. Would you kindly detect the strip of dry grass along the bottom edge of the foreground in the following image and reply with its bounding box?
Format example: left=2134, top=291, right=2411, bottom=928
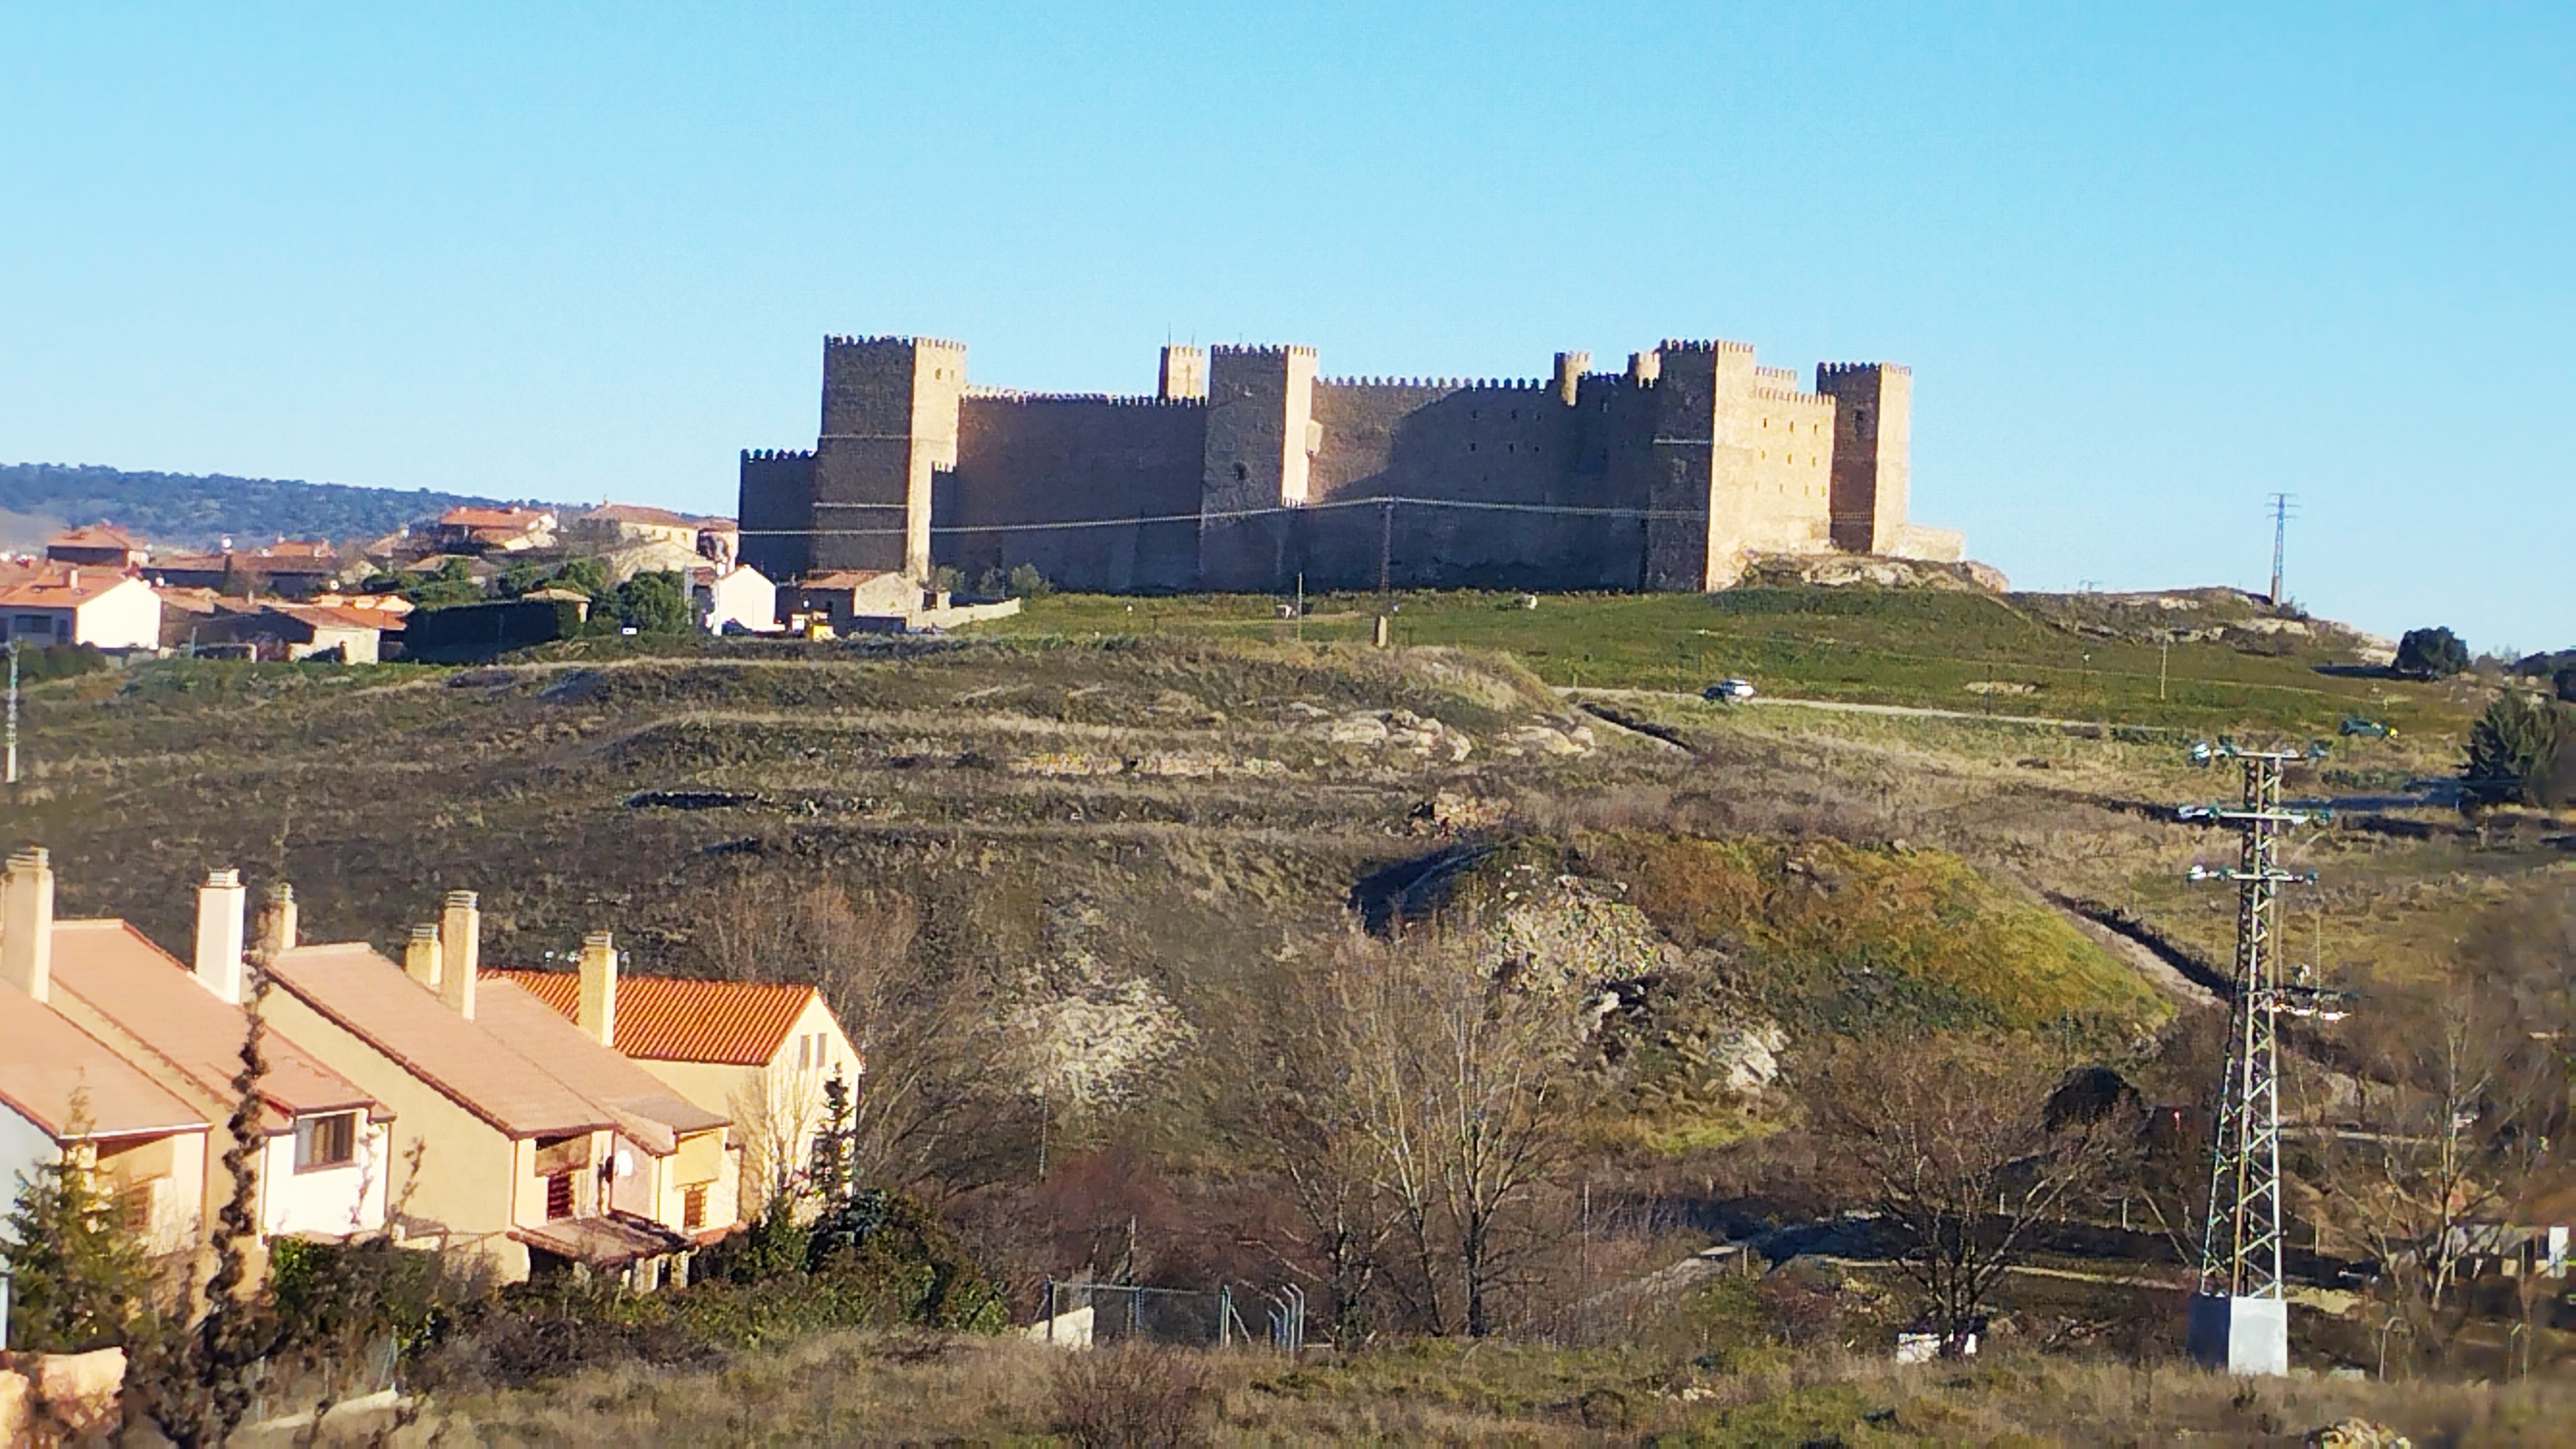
left=425, top=1336, right=2576, bottom=1446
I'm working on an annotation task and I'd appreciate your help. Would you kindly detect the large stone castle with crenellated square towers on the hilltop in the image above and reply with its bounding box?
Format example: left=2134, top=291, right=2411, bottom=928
left=742, top=337, right=1963, bottom=593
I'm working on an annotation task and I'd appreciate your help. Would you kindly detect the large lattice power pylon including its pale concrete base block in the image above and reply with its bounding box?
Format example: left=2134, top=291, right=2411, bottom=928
left=2180, top=740, right=2347, bottom=1375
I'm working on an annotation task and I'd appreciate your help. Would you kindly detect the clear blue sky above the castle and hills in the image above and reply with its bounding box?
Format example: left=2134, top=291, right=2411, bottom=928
left=0, top=3, right=2576, bottom=647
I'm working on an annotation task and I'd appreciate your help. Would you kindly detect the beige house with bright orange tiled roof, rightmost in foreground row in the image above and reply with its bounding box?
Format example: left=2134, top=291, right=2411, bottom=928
left=484, top=936, right=865, bottom=1217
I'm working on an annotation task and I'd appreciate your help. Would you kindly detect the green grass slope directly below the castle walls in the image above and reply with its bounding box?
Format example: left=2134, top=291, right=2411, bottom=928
left=976, top=588, right=2468, bottom=733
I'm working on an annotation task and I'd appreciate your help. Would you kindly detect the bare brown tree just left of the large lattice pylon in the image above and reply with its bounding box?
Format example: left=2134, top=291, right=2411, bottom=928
left=1809, top=1036, right=2138, bottom=1354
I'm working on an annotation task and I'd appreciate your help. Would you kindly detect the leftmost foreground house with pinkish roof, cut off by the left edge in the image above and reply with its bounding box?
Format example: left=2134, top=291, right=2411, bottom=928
left=0, top=848, right=211, bottom=1253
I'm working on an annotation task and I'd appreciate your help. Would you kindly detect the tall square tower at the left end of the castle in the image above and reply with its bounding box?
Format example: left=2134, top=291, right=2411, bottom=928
left=809, top=337, right=966, bottom=578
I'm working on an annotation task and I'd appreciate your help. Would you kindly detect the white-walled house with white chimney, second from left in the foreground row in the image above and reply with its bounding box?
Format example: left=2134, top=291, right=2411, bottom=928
left=52, top=871, right=392, bottom=1240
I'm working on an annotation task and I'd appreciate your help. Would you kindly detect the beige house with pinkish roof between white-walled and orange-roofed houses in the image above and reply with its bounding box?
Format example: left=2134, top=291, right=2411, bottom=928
left=268, top=892, right=734, bottom=1284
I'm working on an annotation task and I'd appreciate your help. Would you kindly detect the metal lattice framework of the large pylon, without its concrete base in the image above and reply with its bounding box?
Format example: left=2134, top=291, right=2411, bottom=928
left=2190, top=743, right=2310, bottom=1299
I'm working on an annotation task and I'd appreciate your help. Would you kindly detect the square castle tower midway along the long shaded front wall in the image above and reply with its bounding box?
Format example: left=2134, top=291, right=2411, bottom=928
left=1198, top=345, right=1324, bottom=590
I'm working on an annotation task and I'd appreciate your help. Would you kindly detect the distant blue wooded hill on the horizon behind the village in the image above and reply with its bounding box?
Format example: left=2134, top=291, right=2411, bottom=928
left=0, top=464, right=543, bottom=549
